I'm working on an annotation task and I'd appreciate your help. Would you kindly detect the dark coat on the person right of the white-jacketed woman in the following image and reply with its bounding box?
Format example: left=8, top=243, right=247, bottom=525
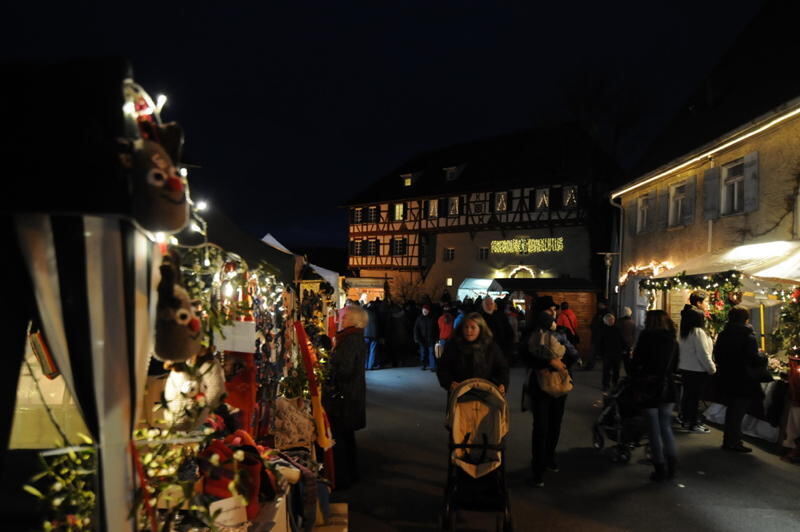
left=714, top=324, right=764, bottom=399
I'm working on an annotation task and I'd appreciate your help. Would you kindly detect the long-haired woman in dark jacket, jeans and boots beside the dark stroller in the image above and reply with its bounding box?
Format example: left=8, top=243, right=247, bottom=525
left=631, top=310, right=678, bottom=482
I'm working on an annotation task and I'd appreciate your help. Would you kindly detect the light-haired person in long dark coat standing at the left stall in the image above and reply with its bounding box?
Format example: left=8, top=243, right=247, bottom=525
left=325, top=306, right=368, bottom=489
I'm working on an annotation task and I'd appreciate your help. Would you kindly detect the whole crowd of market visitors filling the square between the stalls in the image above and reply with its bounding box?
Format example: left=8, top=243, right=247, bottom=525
left=322, top=292, right=765, bottom=487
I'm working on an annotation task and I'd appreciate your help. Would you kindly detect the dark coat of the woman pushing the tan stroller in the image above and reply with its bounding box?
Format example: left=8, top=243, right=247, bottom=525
left=436, top=338, right=508, bottom=391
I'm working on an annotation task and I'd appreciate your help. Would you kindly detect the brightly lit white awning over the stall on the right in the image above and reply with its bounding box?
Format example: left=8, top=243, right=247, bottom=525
left=653, top=240, right=800, bottom=283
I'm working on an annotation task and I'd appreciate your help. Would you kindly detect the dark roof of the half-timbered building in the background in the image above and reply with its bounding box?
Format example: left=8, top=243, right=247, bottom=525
left=347, top=124, right=619, bottom=205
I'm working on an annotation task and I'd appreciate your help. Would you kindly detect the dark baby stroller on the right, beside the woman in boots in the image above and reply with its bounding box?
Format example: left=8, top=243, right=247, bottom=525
left=592, top=377, right=649, bottom=463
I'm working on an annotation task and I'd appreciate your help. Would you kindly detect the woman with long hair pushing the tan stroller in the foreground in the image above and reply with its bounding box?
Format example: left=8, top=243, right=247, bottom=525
left=436, top=312, right=508, bottom=393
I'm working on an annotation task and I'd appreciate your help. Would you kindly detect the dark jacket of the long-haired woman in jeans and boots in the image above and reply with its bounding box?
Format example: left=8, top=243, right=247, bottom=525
left=631, top=329, right=678, bottom=408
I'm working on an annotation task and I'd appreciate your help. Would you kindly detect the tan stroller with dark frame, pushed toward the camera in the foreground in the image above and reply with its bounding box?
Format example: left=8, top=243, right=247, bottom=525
left=442, top=379, right=512, bottom=532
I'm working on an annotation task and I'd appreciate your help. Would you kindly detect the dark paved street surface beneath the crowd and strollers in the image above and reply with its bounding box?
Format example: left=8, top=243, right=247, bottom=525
left=333, top=367, right=800, bottom=532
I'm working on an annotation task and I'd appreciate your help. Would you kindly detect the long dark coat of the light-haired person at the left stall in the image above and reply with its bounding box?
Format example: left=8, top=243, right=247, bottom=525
left=325, top=327, right=367, bottom=430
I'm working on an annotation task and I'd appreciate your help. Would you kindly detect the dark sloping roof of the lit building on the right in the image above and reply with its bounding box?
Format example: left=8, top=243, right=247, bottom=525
left=632, top=0, right=800, bottom=178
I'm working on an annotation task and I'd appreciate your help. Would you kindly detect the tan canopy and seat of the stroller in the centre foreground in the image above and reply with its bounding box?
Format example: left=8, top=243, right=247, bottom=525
left=447, top=379, right=508, bottom=478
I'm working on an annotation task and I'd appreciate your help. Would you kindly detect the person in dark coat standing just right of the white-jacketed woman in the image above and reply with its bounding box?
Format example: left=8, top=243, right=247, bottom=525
left=714, top=307, right=764, bottom=453
